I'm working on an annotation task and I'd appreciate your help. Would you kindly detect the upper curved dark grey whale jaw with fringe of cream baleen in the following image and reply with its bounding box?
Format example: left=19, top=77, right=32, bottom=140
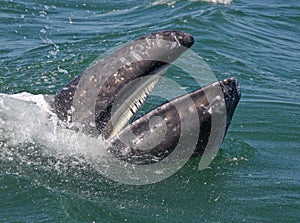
left=54, top=31, right=194, bottom=139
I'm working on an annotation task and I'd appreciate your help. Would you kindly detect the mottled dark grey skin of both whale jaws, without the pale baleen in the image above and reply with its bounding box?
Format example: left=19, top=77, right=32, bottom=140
left=54, top=31, right=241, bottom=164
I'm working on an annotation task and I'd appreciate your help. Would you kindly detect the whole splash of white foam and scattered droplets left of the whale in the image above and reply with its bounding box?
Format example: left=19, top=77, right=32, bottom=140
left=0, top=93, right=115, bottom=193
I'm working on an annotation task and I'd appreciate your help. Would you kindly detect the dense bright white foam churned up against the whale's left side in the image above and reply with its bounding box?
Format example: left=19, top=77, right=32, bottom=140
left=0, top=93, right=106, bottom=157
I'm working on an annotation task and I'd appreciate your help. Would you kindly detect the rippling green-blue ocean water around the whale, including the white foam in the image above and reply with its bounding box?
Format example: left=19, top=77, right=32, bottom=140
left=0, top=0, right=300, bottom=222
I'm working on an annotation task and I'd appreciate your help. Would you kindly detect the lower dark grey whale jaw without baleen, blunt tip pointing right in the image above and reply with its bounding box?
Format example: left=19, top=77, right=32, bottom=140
left=108, top=78, right=241, bottom=164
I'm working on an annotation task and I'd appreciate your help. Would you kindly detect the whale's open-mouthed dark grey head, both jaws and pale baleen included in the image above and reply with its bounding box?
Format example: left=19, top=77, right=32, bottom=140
left=54, top=31, right=241, bottom=164
